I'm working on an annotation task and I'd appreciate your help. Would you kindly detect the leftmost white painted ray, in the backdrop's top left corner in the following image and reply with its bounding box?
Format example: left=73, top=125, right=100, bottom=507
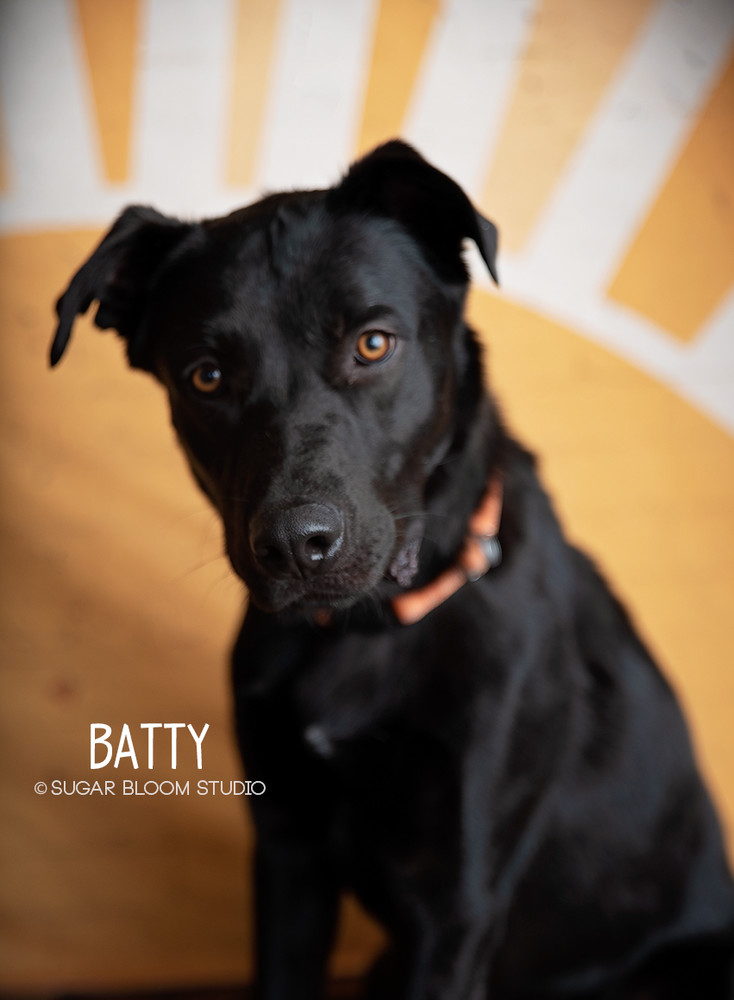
left=0, top=0, right=101, bottom=229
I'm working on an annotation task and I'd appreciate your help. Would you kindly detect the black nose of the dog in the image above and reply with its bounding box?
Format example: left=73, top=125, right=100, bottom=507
left=250, top=503, right=344, bottom=579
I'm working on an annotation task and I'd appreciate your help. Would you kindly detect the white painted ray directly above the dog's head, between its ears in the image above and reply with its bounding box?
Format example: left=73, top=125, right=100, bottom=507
left=257, top=0, right=377, bottom=190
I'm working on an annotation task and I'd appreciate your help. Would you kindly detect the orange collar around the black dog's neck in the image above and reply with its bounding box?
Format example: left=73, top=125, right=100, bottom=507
left=391, top=473, right=503, bottom=625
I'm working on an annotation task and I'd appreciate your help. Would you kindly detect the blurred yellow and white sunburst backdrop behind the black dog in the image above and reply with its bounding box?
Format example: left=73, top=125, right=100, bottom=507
left=0, top=0, right=734, bottom=993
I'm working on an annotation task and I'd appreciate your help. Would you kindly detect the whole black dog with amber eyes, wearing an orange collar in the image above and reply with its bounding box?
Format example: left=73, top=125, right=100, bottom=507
left=51, top=142, right=734, bottom=1000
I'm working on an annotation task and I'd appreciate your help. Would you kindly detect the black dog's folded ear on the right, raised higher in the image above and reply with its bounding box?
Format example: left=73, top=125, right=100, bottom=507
left=330, top=139, right=498, bottom=282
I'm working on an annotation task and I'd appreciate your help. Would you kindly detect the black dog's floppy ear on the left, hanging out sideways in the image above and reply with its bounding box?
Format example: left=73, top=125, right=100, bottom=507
left=50, top=205, right=193, bottom=368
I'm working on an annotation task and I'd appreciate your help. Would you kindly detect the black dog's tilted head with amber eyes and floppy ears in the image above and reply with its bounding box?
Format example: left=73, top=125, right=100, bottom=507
left=51, top=142, right=497, bottom=611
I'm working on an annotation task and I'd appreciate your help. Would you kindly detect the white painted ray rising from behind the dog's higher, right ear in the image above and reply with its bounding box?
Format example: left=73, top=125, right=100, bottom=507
left=403, top=0, right=538, bottom=199
